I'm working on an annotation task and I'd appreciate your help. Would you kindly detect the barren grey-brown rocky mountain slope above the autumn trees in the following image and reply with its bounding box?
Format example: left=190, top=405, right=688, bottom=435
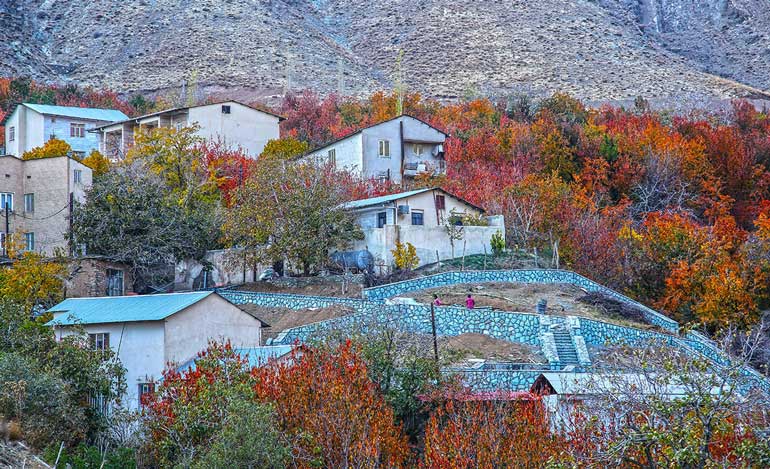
left=0, top=0, right=770, bottom=101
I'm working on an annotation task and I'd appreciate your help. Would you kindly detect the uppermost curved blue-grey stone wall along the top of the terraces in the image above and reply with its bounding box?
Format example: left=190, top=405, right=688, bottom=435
left=363, top=269, right=679, bottom=333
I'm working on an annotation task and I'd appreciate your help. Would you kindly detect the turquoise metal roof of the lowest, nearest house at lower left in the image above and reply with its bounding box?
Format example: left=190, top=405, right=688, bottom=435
left=46, top=291, right=214, bottom=326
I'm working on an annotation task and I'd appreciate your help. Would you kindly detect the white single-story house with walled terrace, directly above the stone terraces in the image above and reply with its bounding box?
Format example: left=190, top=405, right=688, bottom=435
left=343, top=188, right=505, bottom=268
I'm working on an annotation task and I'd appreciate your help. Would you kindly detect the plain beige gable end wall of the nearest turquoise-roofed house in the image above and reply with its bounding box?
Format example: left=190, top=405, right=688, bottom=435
left=164, top=294, right=262, bottom=363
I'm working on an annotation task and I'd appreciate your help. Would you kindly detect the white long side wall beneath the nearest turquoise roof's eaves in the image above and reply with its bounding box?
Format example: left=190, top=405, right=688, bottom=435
left=55, top=320, right=166, bottom=409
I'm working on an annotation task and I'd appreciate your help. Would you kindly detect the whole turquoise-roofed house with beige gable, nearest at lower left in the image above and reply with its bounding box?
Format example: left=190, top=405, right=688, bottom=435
left=47, top=291, right=263, bottom=409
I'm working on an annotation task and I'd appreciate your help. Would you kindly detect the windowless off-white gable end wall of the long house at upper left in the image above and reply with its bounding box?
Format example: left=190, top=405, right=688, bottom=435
left=187, top=102, right=280, bottom=158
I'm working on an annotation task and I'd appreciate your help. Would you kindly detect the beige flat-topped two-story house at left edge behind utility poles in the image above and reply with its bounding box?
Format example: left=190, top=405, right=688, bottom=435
left=0, top=156, right=92, bottom=255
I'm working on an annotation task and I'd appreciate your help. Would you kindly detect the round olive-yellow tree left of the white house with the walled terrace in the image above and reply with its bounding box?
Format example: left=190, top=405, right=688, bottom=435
left=224, top=157, right=362, bottom=274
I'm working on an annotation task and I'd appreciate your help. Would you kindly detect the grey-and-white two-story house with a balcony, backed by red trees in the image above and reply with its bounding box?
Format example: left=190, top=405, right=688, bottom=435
left=308, top=115, right=440, bottom=184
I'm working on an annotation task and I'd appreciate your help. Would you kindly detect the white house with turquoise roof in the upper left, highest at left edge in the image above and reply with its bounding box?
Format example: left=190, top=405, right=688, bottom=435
left=0, top=103, right=128, bottom=158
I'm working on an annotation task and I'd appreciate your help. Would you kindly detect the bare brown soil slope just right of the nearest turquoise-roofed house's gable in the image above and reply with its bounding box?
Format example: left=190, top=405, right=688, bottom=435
left=239, top=304, right=354, bottom=343
